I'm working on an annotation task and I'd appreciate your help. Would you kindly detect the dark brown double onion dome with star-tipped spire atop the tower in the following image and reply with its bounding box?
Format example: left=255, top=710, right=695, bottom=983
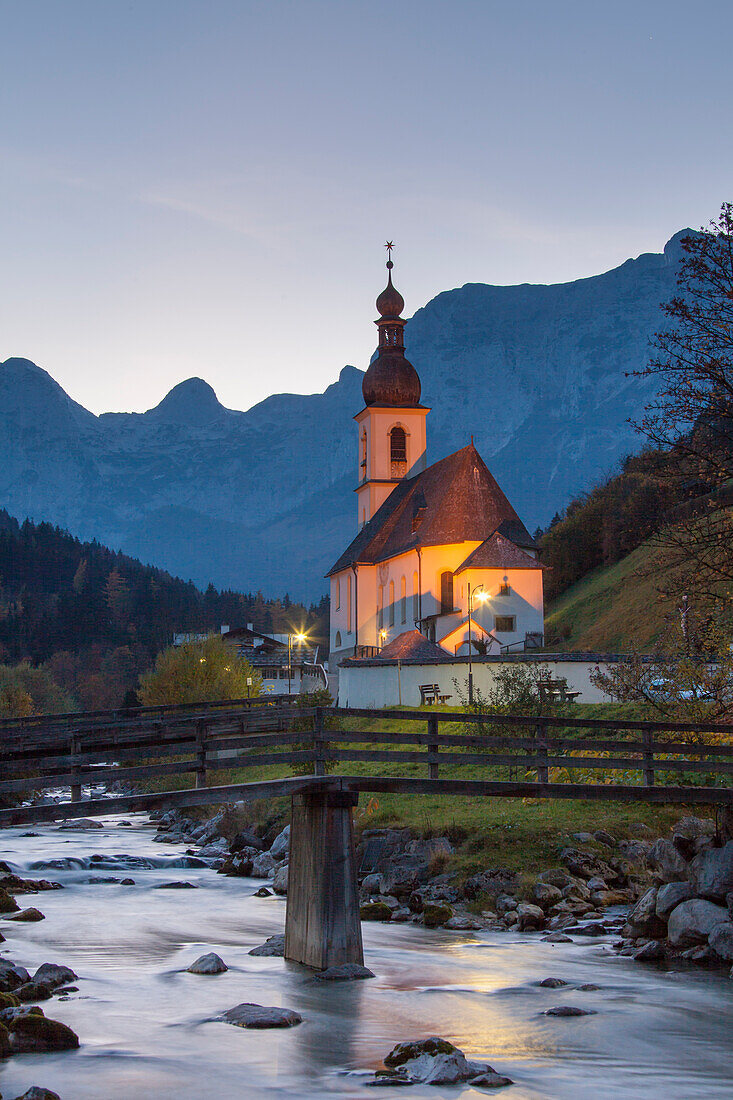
left=361, top=241, right=420, bottom=408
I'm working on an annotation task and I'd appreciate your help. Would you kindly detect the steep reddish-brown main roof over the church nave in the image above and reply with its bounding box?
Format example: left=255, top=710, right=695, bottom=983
left=327, top=442, right=535, bottom=576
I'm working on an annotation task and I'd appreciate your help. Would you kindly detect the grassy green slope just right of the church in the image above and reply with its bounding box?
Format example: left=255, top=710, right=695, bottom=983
left=545, top=543, right=675, bottom=652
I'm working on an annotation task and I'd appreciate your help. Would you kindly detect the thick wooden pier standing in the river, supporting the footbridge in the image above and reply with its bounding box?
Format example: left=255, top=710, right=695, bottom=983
left=285, top=791, right=364, bottom=970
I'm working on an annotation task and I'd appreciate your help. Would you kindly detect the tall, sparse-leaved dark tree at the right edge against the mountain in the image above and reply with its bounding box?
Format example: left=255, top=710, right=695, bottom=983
left=637, top=202, right=733, bottom=616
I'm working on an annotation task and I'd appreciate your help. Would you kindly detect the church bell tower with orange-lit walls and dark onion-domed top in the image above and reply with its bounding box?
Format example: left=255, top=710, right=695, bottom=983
left=354, top=241, right=430, bottom=527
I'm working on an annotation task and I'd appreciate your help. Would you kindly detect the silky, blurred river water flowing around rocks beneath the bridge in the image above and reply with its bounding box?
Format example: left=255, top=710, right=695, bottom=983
left=0, top=817, right=733, bottom=1100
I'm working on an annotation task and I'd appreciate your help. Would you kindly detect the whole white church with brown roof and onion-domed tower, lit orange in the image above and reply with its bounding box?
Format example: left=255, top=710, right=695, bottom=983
left=327, top=253, right=544, bottom=668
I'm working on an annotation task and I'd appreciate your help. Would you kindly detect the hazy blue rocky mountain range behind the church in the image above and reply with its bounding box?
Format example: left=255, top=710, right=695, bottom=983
left=0, top=226, right=683, bottom=600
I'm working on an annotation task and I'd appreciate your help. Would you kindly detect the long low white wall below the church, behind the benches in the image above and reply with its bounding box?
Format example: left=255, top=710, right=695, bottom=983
left=338, top=655, right=611, bottom=708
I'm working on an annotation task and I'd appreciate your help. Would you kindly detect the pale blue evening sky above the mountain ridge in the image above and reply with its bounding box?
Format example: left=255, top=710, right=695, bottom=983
left=0, top=0, right=733, bottom=413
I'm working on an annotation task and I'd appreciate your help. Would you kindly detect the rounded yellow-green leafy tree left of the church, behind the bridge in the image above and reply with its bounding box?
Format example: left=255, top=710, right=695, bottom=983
left=138, top=635, right=262, bottom=706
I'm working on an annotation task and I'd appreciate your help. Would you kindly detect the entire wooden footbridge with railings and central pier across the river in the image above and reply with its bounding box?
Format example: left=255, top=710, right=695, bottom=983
left=0, top=696, right=733, bottom=969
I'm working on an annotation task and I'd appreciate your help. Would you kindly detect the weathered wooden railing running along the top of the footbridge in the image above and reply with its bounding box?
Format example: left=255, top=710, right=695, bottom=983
left=0, top=701, right=733, bottom=824
